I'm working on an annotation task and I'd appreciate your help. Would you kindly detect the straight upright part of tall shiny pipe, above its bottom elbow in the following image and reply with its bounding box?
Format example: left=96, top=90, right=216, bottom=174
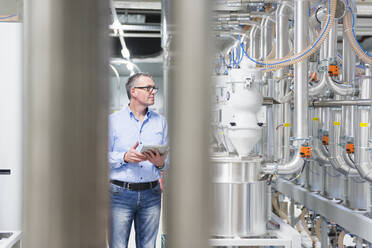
left=294, top=0, right=309, bottom=139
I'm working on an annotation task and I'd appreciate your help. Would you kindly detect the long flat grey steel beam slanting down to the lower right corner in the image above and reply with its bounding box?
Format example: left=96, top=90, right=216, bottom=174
left=274, top=179, right=372, bottom=242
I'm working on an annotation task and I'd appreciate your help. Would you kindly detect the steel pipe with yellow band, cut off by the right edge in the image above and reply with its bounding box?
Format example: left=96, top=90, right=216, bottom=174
left=355, top=65, right=372, bottom=182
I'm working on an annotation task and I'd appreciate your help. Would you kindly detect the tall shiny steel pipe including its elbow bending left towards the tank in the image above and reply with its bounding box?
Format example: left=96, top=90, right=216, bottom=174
left=263, top=0, right=309, bottom=174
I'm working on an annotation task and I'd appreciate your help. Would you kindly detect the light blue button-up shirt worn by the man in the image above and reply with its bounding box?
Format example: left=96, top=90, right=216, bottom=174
left=108, top=106, right=169, bottom=183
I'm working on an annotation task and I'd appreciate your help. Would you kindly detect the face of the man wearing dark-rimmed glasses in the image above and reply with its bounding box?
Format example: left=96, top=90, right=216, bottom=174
left=131, top=76, right=156, bottom=106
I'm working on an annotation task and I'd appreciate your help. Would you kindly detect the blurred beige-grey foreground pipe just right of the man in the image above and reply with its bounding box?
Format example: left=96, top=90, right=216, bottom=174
left=168, top=0, right=212, bottom=248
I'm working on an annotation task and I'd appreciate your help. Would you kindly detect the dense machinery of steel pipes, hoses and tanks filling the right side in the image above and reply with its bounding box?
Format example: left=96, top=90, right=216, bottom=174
left=210, top=0, right=372, bottom=247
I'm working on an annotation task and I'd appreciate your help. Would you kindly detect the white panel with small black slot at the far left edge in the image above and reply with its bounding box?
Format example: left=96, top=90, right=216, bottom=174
left=0, top=23, right=23, bottom=230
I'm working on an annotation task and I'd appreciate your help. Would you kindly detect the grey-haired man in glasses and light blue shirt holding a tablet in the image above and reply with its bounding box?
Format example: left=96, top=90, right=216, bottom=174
left=109, top=73, right=168, bottom=248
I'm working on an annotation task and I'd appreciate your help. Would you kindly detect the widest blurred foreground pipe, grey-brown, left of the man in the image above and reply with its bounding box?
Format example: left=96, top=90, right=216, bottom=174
left=23, top=0, right=109, bottom=248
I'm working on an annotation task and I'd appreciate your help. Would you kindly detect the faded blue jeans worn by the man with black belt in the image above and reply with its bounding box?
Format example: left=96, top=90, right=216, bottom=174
left=110, top=183, right=161, bottom=248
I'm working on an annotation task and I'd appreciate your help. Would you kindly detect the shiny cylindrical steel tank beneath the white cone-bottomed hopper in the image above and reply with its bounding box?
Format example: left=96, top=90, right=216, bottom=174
left=211, top=156, right=269, bottom=237
